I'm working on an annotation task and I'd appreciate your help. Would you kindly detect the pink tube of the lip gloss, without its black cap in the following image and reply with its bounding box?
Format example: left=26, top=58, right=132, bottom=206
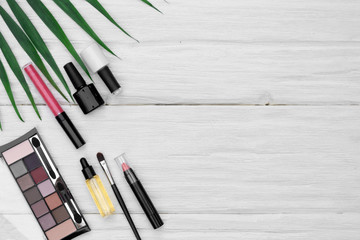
left=24, top=63, right=64, bottom=117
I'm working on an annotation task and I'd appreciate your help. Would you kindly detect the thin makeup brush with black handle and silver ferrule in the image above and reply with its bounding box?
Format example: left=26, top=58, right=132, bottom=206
left=96, top=153, right=141, bottom=240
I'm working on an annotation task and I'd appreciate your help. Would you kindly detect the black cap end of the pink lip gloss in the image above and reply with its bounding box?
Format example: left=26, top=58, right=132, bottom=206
left=56, top=112, right=85, bottom=149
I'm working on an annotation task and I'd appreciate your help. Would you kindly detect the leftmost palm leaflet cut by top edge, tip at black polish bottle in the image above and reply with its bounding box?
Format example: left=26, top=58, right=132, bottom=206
left=7, top=0, right=73, bottom=100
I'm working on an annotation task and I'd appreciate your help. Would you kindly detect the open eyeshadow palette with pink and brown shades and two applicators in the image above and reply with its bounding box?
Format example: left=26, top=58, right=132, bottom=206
left=0, top=129, right=90, bottom=240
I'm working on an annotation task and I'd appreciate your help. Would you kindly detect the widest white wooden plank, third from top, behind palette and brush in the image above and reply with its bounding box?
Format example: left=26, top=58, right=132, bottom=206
left=0, top=106, right=360, bottom=214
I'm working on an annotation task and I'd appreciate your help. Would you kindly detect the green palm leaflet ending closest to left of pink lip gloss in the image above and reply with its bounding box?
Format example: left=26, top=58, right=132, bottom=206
left=0, top=32, right=41, bottom=119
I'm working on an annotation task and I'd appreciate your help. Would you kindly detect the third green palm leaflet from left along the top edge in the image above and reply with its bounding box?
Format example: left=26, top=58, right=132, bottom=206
left=54, top=0, right=117, bottom=57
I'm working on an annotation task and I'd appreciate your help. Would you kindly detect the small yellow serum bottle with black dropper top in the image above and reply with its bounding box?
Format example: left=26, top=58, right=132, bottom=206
left=80, top=158, right=115, bottom=217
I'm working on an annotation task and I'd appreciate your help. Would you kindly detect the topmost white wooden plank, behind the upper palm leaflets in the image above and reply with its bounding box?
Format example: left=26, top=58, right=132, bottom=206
left=2, top=0, right=360, bottom=42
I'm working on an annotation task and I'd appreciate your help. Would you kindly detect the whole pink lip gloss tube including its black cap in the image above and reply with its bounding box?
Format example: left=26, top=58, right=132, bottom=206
left=23, top=63, right=85, bottom=148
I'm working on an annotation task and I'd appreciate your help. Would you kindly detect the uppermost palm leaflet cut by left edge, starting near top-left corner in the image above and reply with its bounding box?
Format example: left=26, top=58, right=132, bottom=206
left=0, top=6, right=68, bottom=101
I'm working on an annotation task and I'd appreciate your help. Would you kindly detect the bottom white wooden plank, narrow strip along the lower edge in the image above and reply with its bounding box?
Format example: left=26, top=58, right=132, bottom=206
left=0, top=213, right=360, bottom=240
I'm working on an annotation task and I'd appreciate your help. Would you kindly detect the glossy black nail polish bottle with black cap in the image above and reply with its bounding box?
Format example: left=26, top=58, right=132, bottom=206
left=64, top=62, right=105, bottom=114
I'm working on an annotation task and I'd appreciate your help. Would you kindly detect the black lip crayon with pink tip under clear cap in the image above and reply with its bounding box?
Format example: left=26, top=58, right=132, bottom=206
left=115, top=153, right=164, bottom=229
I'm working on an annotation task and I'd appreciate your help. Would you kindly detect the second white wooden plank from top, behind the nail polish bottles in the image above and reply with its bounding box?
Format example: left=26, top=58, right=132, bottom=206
left=0, top=43, right=360, bottom=105
